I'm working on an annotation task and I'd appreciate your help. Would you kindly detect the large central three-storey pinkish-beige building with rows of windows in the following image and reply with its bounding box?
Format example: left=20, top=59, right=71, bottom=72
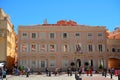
left=18, top=20, right=111, bottom=70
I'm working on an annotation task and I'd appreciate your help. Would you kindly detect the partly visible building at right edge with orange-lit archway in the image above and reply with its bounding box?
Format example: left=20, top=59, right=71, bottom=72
left=107, top=27, right=120, bottom=68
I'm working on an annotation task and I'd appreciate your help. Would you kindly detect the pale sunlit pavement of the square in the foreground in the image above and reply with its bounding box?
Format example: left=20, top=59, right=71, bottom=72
left=4, top=74, right=118, bottom=80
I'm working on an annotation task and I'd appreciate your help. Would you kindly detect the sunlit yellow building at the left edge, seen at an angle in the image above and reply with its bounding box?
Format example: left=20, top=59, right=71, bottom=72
left=0, top=8, right=17, bottom=69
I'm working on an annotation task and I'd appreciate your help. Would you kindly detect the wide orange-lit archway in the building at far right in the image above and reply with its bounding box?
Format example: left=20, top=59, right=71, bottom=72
left=108, top=58, right=120, bottom=68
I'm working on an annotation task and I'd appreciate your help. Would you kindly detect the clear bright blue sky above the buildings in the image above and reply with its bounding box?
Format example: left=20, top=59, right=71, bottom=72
left=0, top=0, right=120, bottom=32
